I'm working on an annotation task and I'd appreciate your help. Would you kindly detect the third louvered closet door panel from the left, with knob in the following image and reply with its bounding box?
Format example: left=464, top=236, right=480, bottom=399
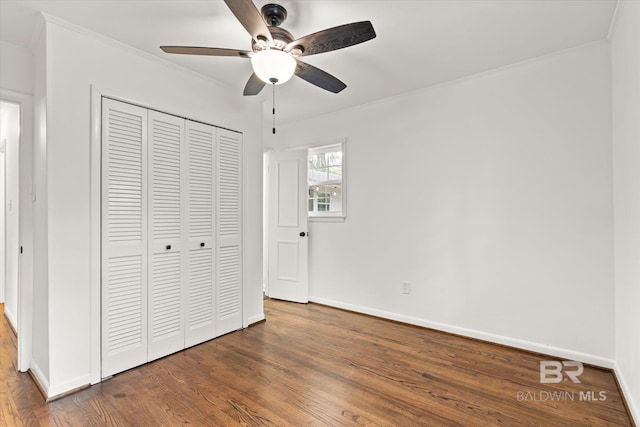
left=185, top=121, right=216, bottom=347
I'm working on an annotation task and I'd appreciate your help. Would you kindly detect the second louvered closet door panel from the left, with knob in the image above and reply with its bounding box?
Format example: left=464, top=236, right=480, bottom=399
left=148, top=111, right=188, bottom=361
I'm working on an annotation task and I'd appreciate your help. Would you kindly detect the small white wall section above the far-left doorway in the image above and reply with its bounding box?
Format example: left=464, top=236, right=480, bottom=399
left=0, top=41, right=34, bottom=94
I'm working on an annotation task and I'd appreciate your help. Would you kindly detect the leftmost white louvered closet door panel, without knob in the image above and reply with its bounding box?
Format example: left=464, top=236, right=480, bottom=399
left=101, top=99, right=147, bottom=378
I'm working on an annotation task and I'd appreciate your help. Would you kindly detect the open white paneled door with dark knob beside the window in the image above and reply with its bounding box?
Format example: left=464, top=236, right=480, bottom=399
left=268, top=150, right=309, bottom=303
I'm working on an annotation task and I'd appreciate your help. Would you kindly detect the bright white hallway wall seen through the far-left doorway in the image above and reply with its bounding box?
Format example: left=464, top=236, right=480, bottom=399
left=0, top=102, right=20, bottom=330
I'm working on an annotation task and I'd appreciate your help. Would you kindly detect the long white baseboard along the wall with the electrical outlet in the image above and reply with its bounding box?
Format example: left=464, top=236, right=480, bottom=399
left=309, top=296, right=614, bottom=369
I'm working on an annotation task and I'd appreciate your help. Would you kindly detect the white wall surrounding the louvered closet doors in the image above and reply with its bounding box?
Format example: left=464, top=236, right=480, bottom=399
left=35, top=17, right=264, bottom=396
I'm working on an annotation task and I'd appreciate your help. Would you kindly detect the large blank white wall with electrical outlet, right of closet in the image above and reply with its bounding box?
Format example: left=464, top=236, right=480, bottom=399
left=279, top=43, right=614, bottom=366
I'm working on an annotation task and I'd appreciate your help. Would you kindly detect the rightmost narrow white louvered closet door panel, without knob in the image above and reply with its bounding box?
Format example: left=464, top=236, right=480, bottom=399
left=216, top=129, right=242, bottom=335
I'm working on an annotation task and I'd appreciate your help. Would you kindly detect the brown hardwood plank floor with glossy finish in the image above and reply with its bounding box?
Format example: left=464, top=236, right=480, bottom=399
left=0, top=300, right=631, bottom=426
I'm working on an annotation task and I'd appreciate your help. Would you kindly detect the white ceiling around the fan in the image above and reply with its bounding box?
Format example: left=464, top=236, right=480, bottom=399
left=0, top=0, right=616, bottom=122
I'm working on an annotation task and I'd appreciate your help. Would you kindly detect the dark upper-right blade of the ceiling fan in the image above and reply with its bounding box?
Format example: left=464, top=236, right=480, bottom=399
left=285, top=21, right=376, bottom=56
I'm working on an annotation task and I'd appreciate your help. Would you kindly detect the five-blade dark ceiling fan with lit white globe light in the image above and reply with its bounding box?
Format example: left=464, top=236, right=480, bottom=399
left=160, top=0, right=376, bottom=96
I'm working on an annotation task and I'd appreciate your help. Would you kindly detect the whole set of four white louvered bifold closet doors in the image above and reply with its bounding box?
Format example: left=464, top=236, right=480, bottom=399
left=101, top=99, right=243, bottom=378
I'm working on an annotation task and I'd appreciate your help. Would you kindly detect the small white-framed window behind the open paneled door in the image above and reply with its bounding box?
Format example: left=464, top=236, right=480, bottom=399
left=307, top=143, right=345, bottom=218
